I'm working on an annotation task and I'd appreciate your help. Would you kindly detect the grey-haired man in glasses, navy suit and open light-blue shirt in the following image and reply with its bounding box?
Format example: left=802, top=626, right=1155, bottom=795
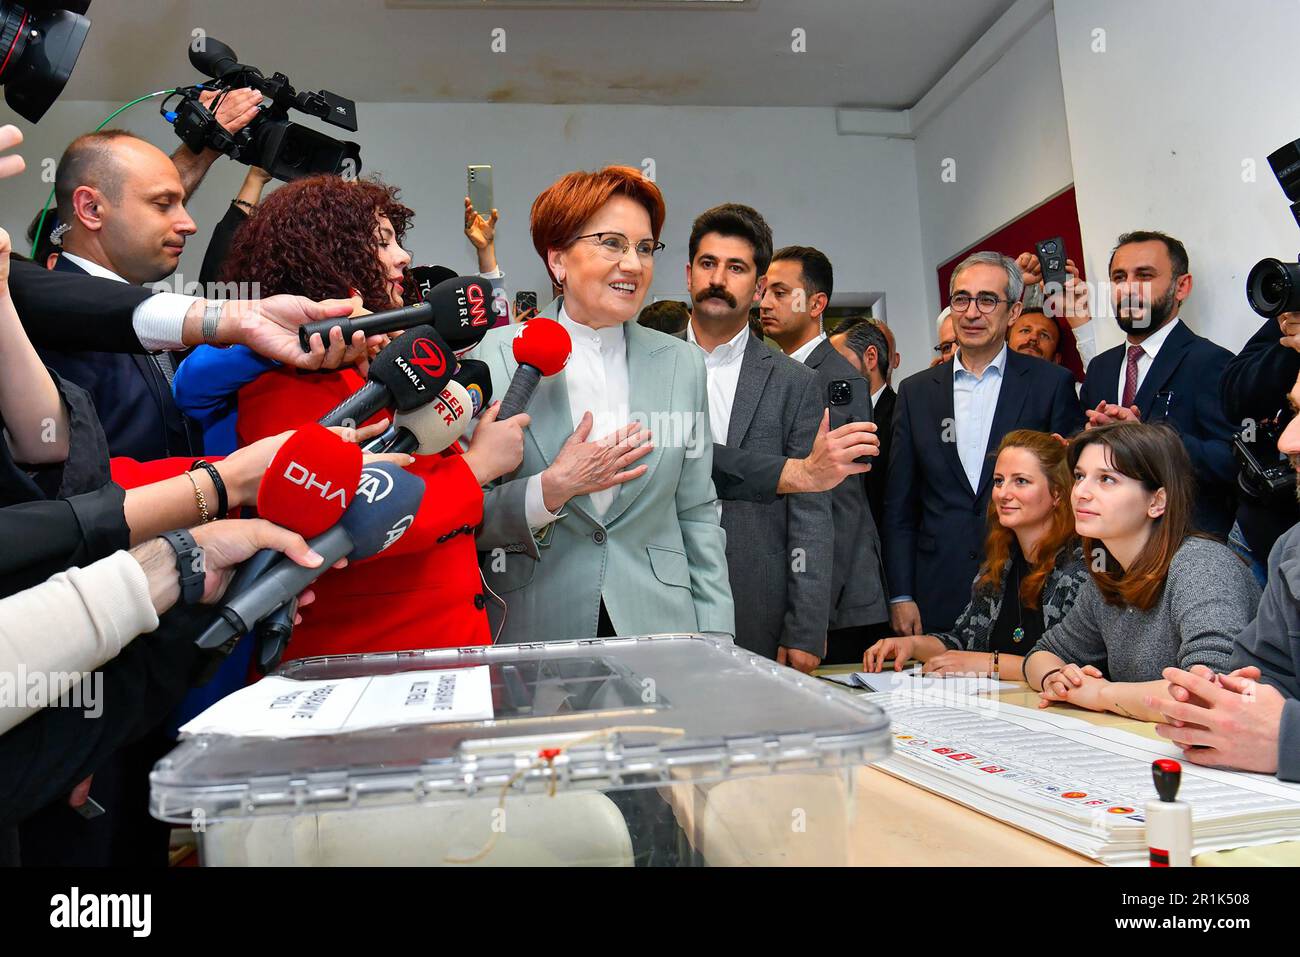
left=884, top=252, right=1083, bottom=635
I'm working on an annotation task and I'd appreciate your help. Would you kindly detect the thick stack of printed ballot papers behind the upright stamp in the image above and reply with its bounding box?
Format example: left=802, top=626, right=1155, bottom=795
left=874, top=692, right=1300, bottom=865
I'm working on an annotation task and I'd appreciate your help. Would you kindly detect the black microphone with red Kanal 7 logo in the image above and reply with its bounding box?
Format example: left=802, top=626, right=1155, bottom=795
left=320, top=325, right=456, bottom=425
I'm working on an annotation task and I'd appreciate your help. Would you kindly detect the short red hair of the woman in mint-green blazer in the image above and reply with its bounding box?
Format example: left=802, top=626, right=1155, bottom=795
left=529, top=166, right=667, bottom=285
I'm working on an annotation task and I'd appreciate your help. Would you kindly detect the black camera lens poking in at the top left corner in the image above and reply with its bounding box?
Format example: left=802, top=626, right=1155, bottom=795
left=0, top=0, right=90, bottom=124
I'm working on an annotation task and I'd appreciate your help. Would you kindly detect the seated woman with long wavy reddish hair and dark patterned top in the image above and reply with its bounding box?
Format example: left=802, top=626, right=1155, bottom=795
left=862, top=429, right=1088, bottom=681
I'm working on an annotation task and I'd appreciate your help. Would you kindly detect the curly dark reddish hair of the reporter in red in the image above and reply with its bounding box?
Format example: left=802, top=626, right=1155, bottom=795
left=221, top=176, right=415, bottom=306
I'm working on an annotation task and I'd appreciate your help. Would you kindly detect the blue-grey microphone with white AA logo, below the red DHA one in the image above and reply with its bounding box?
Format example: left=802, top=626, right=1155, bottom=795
left=195, top=462, right=425, bottom=649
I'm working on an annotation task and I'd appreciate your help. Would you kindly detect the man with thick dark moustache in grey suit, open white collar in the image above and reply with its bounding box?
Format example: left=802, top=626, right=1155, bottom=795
left=686, top=204, right=832, bottom=672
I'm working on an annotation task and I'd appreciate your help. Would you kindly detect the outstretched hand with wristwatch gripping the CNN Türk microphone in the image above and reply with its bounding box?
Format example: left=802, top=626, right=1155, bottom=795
left=195, top=294, right=381, bottom=369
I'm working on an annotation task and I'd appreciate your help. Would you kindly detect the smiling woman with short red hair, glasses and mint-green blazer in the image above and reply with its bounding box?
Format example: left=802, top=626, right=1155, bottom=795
left=476, top=166, right=735, bottom=641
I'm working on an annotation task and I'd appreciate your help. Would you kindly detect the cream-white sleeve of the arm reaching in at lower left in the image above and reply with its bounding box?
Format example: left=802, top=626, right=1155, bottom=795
left=0, top=551, right=159, bottom=735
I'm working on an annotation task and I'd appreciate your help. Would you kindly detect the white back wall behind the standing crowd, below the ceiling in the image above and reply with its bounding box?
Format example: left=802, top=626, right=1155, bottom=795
left=0, top=103, right=930, bottom=377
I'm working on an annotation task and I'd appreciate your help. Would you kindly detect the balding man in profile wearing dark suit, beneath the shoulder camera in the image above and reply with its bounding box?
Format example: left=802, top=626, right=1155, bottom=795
left=40, top=130, right=203, bottom=462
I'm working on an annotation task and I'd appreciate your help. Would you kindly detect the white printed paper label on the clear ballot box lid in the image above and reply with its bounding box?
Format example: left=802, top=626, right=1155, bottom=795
left=181, top=664, right=494, bottom=737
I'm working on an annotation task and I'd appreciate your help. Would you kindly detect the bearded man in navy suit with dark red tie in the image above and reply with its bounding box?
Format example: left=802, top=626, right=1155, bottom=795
left=1079, top=230, right=1237, bottom=538
